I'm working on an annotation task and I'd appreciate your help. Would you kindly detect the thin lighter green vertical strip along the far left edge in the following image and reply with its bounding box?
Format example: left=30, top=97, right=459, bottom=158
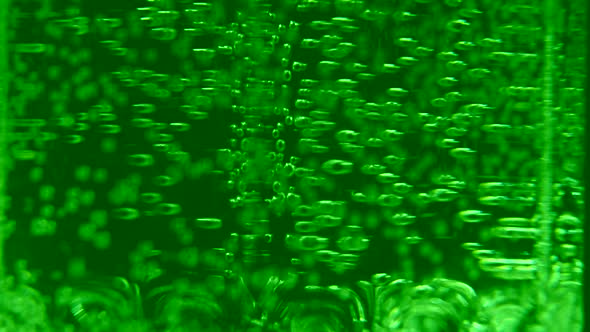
left=0, top=0, right=11, bottom=281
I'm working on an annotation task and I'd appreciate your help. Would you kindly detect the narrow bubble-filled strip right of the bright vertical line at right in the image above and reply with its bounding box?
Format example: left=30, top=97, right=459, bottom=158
left=550, top=2, right=587, bottom=290
